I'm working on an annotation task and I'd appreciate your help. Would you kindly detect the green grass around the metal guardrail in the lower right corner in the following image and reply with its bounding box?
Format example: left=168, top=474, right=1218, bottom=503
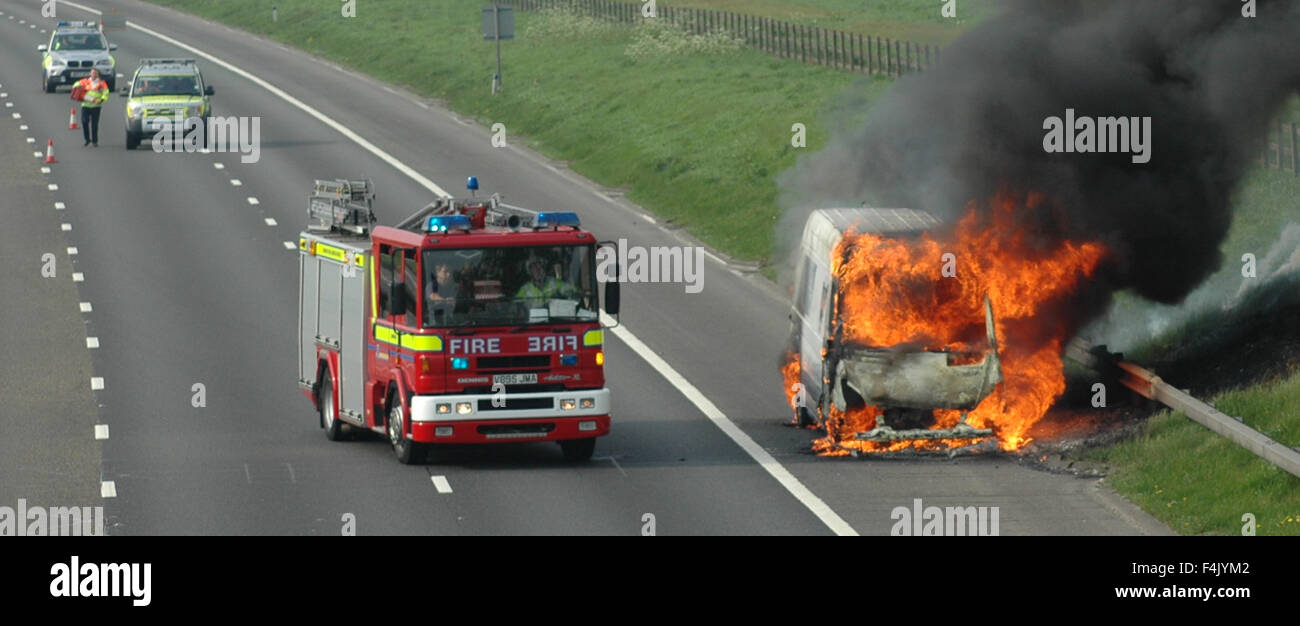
left=1089, top=371, right=1300, bottom=536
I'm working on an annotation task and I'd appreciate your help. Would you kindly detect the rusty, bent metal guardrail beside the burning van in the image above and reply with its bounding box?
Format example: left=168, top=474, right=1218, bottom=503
left=1065, top=339, right=1300, bottom=478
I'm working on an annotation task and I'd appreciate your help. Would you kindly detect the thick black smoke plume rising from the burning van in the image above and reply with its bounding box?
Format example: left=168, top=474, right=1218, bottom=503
left=777, top=0, right=1300, bottom=309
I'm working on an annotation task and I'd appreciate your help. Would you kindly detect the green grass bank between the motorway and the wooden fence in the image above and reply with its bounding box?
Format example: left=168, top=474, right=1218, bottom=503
left=142, top=0, right=892, bottom=261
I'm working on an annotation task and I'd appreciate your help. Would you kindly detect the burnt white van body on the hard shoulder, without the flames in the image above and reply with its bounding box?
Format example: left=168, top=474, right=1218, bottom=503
left=787, top=208, right=1002, bottom=443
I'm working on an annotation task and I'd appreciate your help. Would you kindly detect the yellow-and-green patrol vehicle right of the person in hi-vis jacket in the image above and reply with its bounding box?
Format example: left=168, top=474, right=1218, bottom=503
left=121, top=58, right=213, bottom=149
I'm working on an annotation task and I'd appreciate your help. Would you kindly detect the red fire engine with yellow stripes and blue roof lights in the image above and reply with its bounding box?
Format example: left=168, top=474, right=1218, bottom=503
left=298, top=178, right=619, bottom=464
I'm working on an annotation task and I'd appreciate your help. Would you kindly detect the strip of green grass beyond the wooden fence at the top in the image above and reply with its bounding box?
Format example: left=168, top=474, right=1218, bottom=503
left=664, top=0, right=998, bottom=44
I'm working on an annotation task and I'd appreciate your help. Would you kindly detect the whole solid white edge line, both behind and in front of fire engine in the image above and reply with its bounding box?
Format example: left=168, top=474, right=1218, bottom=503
left=64, top=0, right=857, bottom=535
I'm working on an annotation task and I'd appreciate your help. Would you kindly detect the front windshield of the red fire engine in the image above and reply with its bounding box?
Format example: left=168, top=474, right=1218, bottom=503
left=421, top=245, right=599, bottom=329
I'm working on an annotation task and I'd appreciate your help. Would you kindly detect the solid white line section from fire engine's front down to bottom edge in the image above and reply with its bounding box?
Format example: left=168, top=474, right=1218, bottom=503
left=601, top=312, right=858, bottom=536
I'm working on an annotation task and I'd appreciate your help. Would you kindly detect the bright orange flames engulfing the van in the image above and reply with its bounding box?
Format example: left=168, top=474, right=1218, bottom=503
left=806, top=192, right=1106, bottom=455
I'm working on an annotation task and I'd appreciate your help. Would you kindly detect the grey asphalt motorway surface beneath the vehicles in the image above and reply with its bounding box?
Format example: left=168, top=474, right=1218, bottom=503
left=0, top=0, right=1167, bottom=535
